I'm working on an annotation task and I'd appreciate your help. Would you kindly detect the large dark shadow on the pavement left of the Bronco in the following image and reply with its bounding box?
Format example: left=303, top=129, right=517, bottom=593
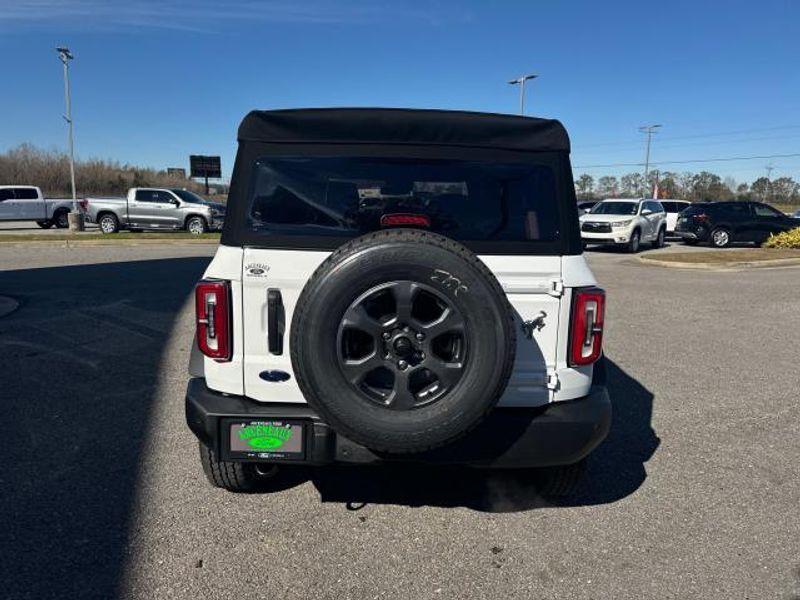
left=0, top=258, right=209, bottom=598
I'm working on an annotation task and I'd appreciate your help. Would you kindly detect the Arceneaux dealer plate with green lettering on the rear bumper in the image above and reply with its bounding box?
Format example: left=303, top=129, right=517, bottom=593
left=223, top=419, right=305, bottom=460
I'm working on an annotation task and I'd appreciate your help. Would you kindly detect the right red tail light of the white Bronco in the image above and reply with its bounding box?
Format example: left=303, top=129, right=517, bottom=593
left=569, top=287, right=606, bottom=367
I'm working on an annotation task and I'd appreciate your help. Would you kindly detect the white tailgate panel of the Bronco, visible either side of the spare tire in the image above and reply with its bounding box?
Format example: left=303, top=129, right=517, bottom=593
left=242, top=248, right=563, bottom=406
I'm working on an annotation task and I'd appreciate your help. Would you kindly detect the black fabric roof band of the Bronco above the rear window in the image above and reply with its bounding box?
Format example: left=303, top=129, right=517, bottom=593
left=239, top=108, right=570, bottom=152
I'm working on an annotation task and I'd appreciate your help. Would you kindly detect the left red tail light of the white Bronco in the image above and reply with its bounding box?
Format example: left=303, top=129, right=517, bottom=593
left=194, top=279, right=231, bottom=362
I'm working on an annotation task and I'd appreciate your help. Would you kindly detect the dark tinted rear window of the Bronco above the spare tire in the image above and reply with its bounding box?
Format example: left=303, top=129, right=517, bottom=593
left=247, top=157, right=559, bottom=241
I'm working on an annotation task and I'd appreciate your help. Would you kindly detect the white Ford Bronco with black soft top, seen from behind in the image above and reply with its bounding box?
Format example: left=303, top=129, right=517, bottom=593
left=186, top=109, right=611, bottom=495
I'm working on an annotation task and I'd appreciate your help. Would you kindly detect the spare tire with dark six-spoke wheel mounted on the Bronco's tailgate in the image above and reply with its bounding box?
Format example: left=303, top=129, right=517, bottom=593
left=291, top=229, right=516, bottom=454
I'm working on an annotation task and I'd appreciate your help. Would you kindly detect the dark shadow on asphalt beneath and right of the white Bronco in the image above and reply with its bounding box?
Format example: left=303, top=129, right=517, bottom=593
left=309, top=359, right=659, bottom=512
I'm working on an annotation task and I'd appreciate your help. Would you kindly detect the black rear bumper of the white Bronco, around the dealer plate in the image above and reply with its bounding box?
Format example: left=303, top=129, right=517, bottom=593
left=186, top=376, right=611, bottom=468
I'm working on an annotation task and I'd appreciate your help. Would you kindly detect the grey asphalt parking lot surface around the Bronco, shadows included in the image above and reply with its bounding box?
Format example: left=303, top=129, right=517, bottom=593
left=0, top=243, right=800, bottom=600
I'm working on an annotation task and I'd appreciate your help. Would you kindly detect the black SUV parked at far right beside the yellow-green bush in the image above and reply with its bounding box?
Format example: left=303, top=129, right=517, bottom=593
left=675, top=202, right=797, bottom=248
